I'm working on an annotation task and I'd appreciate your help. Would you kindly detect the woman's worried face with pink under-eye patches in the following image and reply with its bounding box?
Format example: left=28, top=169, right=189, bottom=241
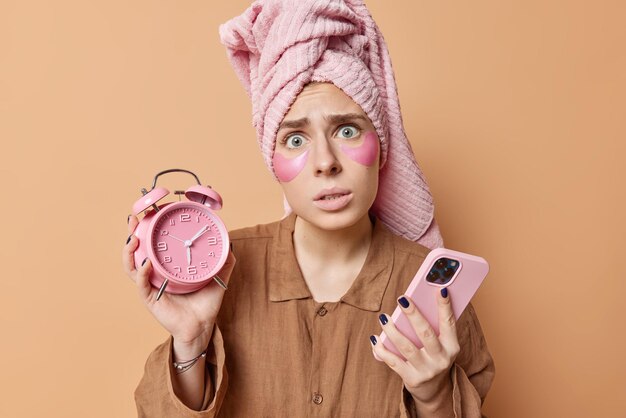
left=272, top=83, right=380, bottom=230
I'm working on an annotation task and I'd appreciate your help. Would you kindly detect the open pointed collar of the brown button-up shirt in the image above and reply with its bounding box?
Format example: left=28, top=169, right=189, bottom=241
left=269, top=213, right=394, bottom=312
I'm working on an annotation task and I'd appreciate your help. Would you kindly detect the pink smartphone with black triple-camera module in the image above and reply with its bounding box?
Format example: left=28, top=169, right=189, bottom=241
left=375, top=248, right=489, bottom=360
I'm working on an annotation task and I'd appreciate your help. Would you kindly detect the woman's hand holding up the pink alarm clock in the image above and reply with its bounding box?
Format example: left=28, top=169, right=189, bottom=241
left=122, top=215, right=236, bottom=356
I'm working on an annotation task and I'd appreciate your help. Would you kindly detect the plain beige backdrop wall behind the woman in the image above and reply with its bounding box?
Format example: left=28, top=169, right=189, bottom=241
left=0, top=0, right=626, bottom=418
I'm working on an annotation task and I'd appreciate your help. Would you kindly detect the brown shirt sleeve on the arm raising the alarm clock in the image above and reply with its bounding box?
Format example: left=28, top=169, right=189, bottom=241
left=135, top=324, right=228, bottom=418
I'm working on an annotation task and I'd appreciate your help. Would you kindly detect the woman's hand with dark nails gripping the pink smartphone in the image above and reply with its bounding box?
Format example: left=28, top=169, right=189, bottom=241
left=372, top=289, right=460, bottom=412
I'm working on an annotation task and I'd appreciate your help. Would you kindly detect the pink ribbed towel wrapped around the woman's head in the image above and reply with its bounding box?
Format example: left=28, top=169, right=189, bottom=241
left=219, top=0, right=443, bottom=249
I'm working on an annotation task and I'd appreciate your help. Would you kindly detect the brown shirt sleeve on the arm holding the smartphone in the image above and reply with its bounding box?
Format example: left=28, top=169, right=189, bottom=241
left=400, top=303, right=495, bottom=418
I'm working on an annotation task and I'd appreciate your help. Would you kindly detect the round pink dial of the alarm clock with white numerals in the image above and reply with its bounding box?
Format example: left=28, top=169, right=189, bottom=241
left=148, top=202, right=229, bottom=282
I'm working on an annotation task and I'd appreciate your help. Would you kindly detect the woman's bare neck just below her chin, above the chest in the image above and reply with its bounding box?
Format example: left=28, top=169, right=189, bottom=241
left=293, top=213, right=373, bottom=263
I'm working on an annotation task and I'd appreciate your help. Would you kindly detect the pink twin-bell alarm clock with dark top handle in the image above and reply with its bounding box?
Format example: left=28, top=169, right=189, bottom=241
left=133, top=168, right=230, bottom=300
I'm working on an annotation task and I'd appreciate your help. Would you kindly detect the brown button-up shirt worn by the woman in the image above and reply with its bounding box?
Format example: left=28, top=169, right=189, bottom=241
left=135, top=214, right=494, bottom=418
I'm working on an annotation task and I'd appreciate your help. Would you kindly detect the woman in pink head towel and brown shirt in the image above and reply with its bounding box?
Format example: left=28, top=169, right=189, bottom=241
left=123, top=0, right=494, bottom=417
